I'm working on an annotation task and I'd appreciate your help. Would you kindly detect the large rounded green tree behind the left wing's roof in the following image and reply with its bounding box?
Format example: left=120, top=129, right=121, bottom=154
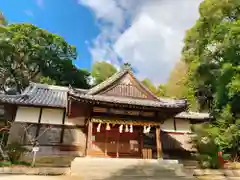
left=0, top=23, right=89, bottom=92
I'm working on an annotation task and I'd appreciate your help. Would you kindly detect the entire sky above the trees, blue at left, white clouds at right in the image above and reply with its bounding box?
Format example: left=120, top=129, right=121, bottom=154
left=0, top=0, right=202, bottom=85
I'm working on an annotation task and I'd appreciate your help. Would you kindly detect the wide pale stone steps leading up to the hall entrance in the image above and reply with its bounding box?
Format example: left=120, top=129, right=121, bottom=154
left=71, top=157, right=195, bottom=180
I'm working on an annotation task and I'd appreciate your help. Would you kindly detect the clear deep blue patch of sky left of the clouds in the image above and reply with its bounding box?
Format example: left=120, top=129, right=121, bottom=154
left=0, top=0, right=99, bottom=70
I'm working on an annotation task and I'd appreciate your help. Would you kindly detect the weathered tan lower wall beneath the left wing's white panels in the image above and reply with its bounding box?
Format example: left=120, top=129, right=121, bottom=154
left=8, top=122, right=86, bottom=156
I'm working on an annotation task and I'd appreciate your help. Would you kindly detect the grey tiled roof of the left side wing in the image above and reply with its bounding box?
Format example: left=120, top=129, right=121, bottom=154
left=0, top=83, right=69, bottom=108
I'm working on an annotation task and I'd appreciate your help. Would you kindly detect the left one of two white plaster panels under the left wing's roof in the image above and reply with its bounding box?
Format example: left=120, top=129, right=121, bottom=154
left=15, top=106, right=40, bottom=123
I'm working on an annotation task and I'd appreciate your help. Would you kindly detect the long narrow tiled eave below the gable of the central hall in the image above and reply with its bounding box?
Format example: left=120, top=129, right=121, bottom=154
left=69, top=91, right=187, bottom=109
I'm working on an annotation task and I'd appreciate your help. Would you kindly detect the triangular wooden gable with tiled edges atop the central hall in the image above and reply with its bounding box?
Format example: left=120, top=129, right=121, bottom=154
left=89, top=69, right=158, bottom=101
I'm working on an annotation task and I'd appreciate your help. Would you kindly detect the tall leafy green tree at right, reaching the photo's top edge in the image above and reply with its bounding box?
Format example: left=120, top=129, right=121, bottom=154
left=183, top=0, right=240, bottom=112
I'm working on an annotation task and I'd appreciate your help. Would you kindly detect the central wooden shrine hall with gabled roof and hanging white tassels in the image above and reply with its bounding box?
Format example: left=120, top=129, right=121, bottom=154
left=67, top=69, right=187, bottom=158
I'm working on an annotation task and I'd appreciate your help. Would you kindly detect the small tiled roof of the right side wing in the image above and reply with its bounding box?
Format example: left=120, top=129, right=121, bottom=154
left=175, top=111, right=212, bottom=120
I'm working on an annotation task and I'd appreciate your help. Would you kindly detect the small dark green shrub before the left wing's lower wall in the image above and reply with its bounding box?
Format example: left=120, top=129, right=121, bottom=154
left=5, top=142, right=28, bottom=164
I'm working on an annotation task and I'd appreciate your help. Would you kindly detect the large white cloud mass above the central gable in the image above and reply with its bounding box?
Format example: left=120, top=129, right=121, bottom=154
left=78, top=0, right=201, bottom=83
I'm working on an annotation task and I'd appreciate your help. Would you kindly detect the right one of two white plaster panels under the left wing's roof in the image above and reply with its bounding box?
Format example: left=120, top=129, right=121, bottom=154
left=41, top=108, right=64, bottom=124
